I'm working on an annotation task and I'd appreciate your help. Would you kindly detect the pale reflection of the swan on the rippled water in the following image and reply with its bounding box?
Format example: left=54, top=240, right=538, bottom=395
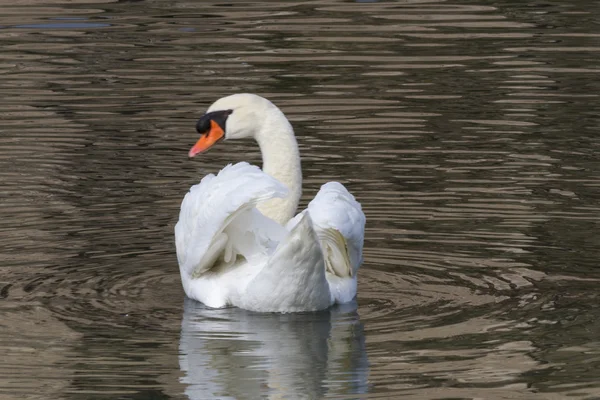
left=179, top=299, right=369, bottom=399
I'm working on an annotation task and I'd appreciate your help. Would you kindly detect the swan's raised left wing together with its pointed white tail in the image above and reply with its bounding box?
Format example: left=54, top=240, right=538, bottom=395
left=175, top=163, right=334, bottom=312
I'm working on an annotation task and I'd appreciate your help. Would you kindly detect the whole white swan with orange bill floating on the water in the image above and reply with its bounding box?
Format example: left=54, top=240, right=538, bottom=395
left=175, top=93, right=365, bottom=312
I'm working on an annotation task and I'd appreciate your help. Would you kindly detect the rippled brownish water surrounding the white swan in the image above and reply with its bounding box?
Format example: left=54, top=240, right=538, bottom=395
left=0, top=0, right=600, bottom=399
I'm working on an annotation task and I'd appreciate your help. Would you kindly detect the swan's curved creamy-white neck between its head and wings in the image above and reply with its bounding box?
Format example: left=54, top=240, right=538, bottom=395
left=255, top=106, right=302, bottom=225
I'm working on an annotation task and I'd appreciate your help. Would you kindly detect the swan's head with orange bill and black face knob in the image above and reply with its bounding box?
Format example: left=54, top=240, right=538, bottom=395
left=189, top=93, right=279, bottom=157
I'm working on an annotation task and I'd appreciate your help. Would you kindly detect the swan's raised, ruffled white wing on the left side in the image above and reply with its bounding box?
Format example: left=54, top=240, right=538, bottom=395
left=175, top=162, right=287, bottom=278
